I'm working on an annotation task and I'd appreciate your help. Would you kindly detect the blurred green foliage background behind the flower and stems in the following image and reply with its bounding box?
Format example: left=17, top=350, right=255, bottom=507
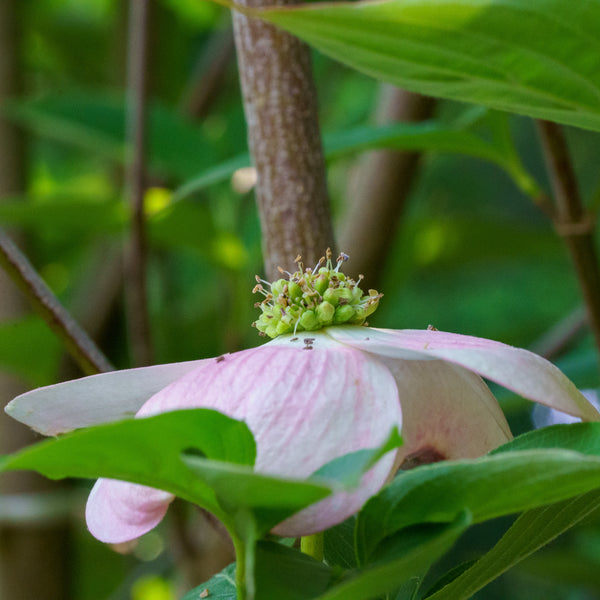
left=0, top=0, right=600, bottom=600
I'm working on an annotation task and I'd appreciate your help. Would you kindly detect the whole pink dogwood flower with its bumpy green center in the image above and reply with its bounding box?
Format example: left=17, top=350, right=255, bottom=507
left=6, top=253, right=600, bottom=543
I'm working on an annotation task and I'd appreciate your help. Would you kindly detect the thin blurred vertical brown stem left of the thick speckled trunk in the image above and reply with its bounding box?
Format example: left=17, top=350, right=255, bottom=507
left=125, top=0, right=152, bottom=365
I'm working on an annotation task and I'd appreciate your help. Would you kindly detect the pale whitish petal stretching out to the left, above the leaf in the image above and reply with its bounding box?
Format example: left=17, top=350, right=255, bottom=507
left=4, top=359, right=210, bottom=435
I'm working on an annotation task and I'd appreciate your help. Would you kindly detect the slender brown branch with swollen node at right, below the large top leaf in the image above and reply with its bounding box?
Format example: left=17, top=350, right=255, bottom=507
left=538, top=121, right=600, bottom=360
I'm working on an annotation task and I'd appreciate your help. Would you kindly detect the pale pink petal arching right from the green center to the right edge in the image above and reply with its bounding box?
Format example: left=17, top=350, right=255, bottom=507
left=327, top=327, right=600, bottom=421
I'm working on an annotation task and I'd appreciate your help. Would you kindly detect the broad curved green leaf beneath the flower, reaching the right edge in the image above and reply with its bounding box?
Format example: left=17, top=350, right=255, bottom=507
left=356, top=449, right=600, bottom=561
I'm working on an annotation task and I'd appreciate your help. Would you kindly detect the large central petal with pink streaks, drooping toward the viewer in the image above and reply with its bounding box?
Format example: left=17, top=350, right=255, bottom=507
left=139, top=333, right=402, bottom=535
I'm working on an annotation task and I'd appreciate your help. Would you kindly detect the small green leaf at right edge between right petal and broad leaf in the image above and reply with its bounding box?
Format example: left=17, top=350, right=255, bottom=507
left=490, top=423, right=600, bottom=456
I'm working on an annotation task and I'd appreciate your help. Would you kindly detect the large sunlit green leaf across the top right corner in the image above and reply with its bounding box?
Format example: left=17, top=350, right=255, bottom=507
left=254, top=0, right=600, bottom=131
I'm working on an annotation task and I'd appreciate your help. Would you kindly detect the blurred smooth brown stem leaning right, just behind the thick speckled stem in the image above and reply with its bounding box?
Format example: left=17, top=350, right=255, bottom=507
left=339, top=85, right=435, bottom=287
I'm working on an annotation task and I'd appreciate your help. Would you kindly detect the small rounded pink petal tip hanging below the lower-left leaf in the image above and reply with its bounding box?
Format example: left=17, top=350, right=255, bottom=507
left=85, top=479, right=174, bottom=544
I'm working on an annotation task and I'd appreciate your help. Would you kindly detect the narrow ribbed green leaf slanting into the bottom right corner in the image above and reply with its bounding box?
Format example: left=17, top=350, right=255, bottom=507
left=426, top=490, right=600, bottom=600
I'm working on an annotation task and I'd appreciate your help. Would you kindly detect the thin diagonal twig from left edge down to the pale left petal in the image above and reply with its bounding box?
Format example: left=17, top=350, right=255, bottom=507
left=0, top=230, right=114, bottom=375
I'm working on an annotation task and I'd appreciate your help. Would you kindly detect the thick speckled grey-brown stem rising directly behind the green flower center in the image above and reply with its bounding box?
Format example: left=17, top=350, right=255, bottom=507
left=233, top=0, right=334, bottom=277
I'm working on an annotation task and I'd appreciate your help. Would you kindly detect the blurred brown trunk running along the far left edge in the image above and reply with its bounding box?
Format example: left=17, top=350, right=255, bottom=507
left=0, top=0, right=70, bottom=600
